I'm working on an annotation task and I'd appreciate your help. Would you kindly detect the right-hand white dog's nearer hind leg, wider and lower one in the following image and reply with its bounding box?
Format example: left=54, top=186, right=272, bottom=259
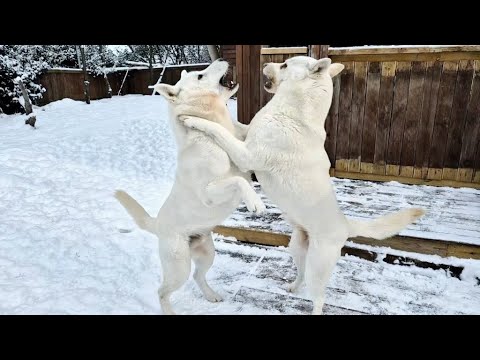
left=305, top=239, right=345, bottom=315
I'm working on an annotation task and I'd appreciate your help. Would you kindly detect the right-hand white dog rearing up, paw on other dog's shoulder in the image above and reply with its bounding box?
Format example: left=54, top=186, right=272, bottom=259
left=180, top=56, right=424, bottom=314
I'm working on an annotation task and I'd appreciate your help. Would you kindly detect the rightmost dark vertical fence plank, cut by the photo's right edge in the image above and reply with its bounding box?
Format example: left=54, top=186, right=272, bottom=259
left=459, top=61, right=480, bottom=172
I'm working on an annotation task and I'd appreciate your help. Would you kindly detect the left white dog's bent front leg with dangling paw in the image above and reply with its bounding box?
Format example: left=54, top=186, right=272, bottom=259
left=206, top=176, right=265, bottom=214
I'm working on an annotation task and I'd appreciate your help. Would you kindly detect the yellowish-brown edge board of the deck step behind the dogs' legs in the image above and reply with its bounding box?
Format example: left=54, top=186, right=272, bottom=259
left=213, top=225, right=480, bottom=259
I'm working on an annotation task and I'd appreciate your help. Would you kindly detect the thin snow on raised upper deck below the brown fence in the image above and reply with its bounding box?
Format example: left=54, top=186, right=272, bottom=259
left=225, top=178, right=480, bottom=245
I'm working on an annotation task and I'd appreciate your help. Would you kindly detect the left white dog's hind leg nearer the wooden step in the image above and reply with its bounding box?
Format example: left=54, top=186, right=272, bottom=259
left=190, top=234, right=223, bottom=302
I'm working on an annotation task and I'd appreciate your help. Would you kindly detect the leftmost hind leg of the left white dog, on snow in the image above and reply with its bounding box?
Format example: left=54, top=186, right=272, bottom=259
left=158, top=237, right=191, bottom=315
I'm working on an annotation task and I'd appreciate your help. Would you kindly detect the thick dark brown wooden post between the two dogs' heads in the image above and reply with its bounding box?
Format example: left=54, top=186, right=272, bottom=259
left=236, top=45, right=262, bottom=124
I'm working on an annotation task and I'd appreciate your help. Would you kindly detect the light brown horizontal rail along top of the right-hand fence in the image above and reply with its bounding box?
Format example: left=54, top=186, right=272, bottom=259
left=330, top=51, right=480, bottom=62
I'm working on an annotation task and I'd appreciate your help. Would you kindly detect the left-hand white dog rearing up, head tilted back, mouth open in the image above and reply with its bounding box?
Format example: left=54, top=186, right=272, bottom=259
left=115, top=59, right=265, bottom=314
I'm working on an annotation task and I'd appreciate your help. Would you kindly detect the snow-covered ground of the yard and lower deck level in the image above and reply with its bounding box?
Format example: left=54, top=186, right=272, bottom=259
left=0, top=95, right=480, bottom=314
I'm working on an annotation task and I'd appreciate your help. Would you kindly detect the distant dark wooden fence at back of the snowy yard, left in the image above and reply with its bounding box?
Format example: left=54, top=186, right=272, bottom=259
left=39, top=64, right=208, bottom=105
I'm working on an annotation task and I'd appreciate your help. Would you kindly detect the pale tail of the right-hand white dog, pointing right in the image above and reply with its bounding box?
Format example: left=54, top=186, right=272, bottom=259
left=348, top=208, right=425, bottom=240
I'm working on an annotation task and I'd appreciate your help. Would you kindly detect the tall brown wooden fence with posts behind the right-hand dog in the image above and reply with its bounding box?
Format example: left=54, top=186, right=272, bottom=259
left=236, top=45, right=480, bottom=188
